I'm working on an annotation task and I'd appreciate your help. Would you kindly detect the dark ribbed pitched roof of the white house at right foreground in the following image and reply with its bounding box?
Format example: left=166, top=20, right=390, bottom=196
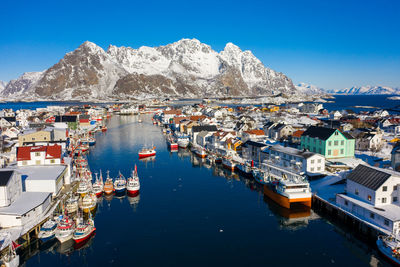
left=347, top=164, right=392, bottom=190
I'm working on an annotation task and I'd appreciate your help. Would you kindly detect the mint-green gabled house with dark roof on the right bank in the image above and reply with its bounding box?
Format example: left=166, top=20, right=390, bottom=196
left=300, top=126, right=355, bottom=159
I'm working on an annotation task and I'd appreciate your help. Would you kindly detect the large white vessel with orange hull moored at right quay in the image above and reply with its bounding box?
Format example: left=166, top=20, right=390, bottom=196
left=264, top=177, right=312, bottom=209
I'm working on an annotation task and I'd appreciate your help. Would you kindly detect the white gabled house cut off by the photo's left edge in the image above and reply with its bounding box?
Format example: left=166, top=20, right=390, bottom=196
left=0, top=169, right=22, bottom=207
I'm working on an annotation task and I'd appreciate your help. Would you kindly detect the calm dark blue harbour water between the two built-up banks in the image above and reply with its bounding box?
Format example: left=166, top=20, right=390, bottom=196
left=20, top=116, right=390, bottom=267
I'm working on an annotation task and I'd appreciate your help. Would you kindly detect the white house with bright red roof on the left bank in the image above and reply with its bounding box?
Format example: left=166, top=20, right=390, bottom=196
left=17, top=145, right=62, bottom=166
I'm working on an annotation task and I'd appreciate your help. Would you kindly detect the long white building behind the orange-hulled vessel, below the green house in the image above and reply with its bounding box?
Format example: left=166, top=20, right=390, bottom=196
left=267, top=145, right=325, bottom=178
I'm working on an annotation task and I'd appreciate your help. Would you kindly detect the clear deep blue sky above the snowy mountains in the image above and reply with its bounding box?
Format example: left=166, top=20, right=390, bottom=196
left=0, top=0, right=400, bottom=89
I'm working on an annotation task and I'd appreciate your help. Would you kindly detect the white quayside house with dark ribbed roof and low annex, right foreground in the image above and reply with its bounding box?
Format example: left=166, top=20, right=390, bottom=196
left=336, top=164, right=400, bottom=236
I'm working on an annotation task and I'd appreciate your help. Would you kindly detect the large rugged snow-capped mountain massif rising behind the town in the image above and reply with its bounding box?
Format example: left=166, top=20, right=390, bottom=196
left=3, top=39, right=296, bottom=99
